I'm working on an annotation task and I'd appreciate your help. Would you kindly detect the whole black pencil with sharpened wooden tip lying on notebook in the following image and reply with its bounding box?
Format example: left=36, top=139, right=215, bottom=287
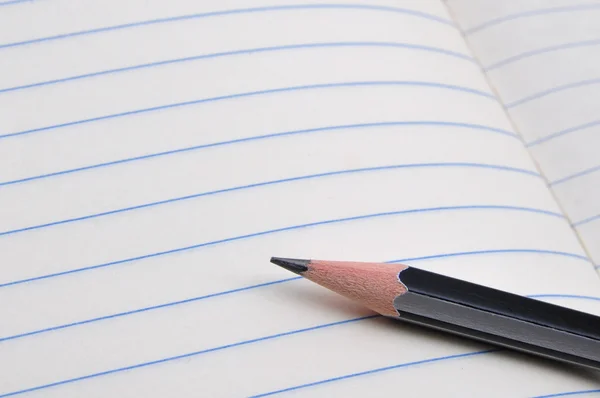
left=271, top=257, right=600, bottom=370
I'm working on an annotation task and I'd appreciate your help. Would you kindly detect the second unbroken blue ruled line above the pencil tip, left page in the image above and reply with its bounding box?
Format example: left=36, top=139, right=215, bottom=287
left=0, top=163, right=541, bottom=237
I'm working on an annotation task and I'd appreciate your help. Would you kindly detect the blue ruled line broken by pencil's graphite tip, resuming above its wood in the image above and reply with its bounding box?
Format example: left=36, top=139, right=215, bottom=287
left=0, top=249, right=589, bottom=342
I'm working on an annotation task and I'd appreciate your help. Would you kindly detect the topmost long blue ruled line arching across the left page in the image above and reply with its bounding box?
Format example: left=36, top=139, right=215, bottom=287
left=0, top=4, right=454, bottom=49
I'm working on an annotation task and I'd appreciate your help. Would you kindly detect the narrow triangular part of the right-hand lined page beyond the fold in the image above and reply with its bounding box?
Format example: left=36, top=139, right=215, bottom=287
left=448, top=0, right=600, bottom=265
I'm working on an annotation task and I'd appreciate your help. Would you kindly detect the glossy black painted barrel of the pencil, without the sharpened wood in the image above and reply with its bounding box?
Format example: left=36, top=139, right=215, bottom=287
left=394, top=267, right=600, bottom=369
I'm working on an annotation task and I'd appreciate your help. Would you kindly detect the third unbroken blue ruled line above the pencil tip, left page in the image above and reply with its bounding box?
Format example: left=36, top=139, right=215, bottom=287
left=0, top=120, right=519, bottom=187
